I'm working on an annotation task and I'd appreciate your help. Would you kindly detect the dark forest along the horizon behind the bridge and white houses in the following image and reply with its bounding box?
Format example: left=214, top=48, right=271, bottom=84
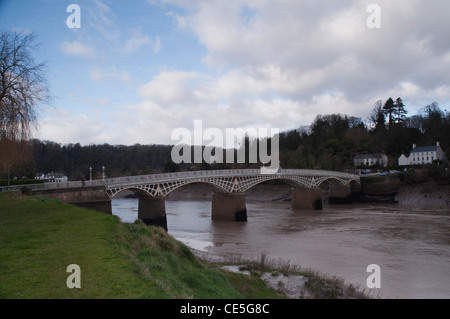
left=0, top=98, right=450, bottom=180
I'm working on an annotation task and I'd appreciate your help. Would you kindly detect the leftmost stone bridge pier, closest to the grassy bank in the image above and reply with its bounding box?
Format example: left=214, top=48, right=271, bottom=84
left=138, top=197, right=167, bottom=231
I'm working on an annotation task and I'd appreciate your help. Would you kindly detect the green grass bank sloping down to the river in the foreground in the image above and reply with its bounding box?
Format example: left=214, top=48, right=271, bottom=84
left=0, top=193, right=280, bottom=299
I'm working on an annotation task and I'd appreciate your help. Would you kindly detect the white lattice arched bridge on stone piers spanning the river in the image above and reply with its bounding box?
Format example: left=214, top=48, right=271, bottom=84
left=4, top=169, right=360, bottom=229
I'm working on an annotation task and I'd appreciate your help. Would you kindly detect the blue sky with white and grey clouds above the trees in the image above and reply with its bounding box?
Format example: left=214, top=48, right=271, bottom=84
left=0, top=0, right=450, bottom=145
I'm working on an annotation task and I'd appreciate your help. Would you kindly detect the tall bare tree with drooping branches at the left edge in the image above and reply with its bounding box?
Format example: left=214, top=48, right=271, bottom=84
left=0, top=31, right=50, bottom=175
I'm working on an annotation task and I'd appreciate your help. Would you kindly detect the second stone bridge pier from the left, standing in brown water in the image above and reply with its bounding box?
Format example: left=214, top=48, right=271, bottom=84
left=211, top=193, right=247, bottom=222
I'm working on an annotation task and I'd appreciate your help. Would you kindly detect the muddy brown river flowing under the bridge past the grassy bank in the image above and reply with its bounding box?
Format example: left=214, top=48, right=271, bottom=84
left=112, top=198, right=450, bottom=299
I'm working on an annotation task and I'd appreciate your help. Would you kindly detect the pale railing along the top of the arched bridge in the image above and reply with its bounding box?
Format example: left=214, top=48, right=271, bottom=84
left=0, top=169, right=359, bottom=191
